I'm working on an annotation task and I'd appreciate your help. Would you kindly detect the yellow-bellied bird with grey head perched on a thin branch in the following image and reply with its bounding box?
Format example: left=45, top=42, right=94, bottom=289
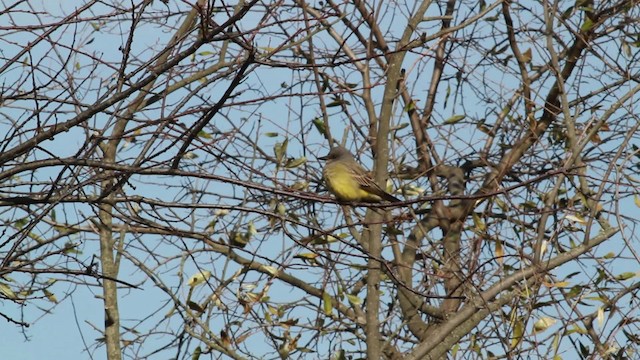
left=318, top=145, right=401, bottom=203
